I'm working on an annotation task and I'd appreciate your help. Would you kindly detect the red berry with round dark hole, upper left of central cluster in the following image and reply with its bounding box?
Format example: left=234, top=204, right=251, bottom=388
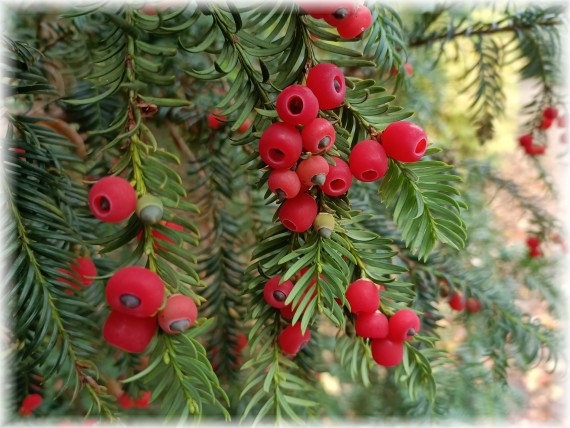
left=275, top=85, right=319, bottom=126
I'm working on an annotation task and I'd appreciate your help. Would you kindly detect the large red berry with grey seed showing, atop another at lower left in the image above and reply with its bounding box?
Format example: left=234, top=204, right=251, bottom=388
left=105, top=266, right=164, bottom=317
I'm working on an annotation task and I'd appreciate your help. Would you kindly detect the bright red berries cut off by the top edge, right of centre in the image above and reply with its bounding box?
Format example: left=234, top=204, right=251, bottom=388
left=299, top=0, right=372, bottom=39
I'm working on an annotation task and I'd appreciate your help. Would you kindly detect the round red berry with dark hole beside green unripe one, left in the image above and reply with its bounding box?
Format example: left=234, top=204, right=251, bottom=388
left=89, top=176, right=137, bottom=223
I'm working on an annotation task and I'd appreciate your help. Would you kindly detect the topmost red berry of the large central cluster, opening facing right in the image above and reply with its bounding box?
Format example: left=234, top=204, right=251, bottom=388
left=306, top=63, right=346, bottom=110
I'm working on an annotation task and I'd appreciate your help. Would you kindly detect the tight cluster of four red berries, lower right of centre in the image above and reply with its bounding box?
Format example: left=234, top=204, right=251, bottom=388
left=346, top=278, right=420, bottom=367
